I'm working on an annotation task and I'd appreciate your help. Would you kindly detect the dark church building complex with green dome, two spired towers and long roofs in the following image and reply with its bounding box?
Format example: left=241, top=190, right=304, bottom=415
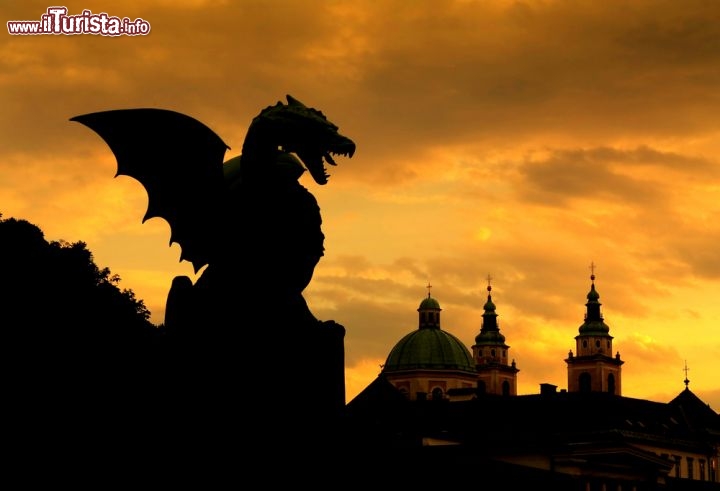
left=345, top=272, right=720, bottom=491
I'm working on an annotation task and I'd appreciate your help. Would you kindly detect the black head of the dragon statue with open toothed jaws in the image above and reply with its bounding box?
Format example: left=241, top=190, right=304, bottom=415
left=248, top=95, right=355, bottom=185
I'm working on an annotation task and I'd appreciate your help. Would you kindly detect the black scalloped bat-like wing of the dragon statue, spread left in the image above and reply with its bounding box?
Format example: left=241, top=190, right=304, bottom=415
left=70, top=108, right=230, bottom=273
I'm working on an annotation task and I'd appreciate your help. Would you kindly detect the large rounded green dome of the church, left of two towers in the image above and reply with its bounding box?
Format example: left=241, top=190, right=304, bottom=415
left=383, top=328, right=475, bottom=372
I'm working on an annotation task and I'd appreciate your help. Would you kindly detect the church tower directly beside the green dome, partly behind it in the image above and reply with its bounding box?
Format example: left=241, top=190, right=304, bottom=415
left=472, top=276, right=520, bottom=396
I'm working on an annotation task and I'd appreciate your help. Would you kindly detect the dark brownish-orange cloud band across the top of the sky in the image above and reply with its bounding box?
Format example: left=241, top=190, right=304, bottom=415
left=0, top=0, right=720, bottom=180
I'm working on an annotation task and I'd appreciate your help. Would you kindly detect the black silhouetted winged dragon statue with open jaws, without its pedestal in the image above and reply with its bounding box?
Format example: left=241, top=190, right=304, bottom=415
left=71, top=95, right=355, bottom=321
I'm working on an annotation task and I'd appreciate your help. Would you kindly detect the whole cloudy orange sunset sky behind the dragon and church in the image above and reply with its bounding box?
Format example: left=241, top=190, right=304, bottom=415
left=0, top=0, right=720, bottom=411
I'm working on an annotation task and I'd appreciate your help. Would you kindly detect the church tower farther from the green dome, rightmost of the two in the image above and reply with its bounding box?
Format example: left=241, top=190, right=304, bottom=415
left=565, top=264, right=625, bottom=396
